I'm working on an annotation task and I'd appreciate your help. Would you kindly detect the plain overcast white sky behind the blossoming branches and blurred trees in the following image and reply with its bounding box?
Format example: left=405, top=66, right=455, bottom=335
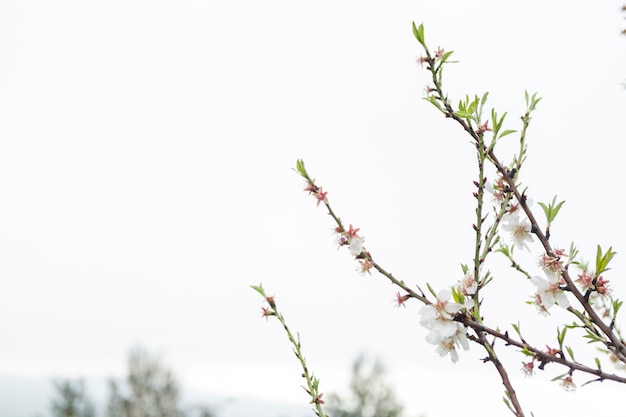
left=0, top=0, right=626, bottom=417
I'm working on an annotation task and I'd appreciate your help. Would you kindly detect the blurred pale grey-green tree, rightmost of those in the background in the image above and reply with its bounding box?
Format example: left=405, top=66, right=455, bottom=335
left=328, top=355, right=404, bottom=417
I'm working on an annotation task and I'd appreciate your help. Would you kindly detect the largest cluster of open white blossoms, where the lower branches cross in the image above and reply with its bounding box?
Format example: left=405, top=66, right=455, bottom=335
left=419, top=289, right=469, bottom=362
